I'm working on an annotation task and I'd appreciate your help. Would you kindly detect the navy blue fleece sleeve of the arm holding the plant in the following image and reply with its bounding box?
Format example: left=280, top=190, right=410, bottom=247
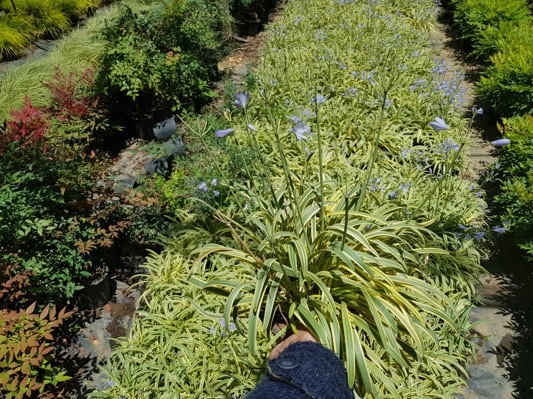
left=246, top=342, right=354, bottom=399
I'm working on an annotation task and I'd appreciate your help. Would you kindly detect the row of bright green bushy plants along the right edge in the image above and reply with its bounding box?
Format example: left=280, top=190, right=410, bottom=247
left=451, top=0, right=533, bottom=258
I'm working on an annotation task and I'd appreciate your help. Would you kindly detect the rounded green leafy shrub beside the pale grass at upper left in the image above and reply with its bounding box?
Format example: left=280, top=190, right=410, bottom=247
left=98, top=0, right=223, bottom=115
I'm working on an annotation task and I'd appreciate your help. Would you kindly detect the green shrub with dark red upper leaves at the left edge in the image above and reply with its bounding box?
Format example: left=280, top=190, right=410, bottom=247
left=0, top=87, right=124, bottom=303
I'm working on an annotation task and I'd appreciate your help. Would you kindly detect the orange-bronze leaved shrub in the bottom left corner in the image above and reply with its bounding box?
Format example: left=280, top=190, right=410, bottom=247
left=0, top=303, right=72, bottom=399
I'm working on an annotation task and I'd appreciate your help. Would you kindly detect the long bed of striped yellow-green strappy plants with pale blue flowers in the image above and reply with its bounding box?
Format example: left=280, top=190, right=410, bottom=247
left=92, top=0, right=486, bottom=398
